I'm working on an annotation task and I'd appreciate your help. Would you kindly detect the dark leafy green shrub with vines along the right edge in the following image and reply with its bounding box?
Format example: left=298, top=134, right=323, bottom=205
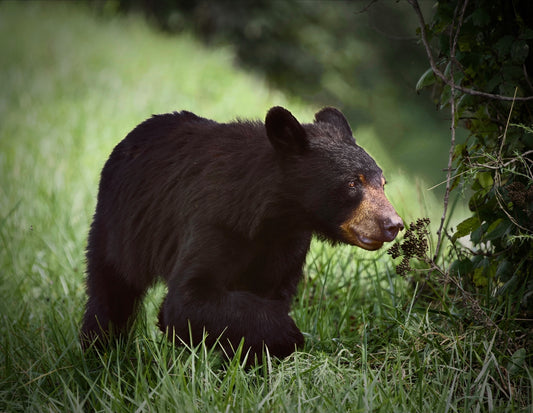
left=418, top=0, right=533, bottom=318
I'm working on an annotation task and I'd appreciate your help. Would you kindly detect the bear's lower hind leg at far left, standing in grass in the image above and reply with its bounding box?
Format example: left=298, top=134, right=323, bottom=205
left=80, top=257, right=144, bottom=348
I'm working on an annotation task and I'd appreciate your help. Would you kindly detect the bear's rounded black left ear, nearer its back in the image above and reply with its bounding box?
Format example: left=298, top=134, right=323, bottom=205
left=265, top=106, right=308, bottom=155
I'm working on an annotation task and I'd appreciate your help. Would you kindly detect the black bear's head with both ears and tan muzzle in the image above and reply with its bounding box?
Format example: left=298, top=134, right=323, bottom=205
left=265, top=107, right=403, bottom=250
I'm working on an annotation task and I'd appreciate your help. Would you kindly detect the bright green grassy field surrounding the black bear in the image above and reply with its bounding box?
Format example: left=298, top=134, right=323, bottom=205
left=0, top=2, right=533, bottom=412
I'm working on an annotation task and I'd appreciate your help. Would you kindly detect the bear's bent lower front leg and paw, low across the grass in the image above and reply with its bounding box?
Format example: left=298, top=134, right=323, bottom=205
left=159, top=283, right=304, bottom=362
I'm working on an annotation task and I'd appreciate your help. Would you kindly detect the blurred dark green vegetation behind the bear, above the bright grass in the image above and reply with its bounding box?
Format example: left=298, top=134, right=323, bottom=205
left=91, top=0, right=458, bottom=190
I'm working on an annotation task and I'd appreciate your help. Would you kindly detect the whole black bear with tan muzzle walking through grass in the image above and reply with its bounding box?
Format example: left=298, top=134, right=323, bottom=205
left=81, top=107, right=403, bottom=357
